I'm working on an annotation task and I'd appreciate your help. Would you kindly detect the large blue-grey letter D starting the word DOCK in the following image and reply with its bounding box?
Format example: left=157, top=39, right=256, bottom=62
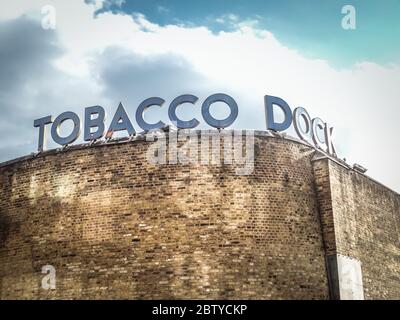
left=264, top=96, right=292, bottom=131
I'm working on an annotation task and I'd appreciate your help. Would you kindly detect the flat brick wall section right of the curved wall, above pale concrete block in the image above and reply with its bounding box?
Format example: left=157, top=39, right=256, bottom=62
left=314, top=158, right=400, bottom=299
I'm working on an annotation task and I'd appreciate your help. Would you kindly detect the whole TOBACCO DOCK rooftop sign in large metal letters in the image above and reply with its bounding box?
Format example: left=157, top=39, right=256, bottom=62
left=34, top=93, right=336, bottom=156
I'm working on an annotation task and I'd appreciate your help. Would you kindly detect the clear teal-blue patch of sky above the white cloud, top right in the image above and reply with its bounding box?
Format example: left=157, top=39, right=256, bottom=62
left=98, top=0, right=400, bottom=67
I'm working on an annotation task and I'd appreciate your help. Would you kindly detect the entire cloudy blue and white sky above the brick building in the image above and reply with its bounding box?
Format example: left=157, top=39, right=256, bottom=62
left=0, top=0, right=400, bottom=192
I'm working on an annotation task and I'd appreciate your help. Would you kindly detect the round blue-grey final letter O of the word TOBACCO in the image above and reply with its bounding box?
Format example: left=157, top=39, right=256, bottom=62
left=201, top=93, right=239, bottom=129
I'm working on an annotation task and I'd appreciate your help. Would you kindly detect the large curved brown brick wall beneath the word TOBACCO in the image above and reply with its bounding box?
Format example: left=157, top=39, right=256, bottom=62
left=0, top=132, right=330, bottom=299
